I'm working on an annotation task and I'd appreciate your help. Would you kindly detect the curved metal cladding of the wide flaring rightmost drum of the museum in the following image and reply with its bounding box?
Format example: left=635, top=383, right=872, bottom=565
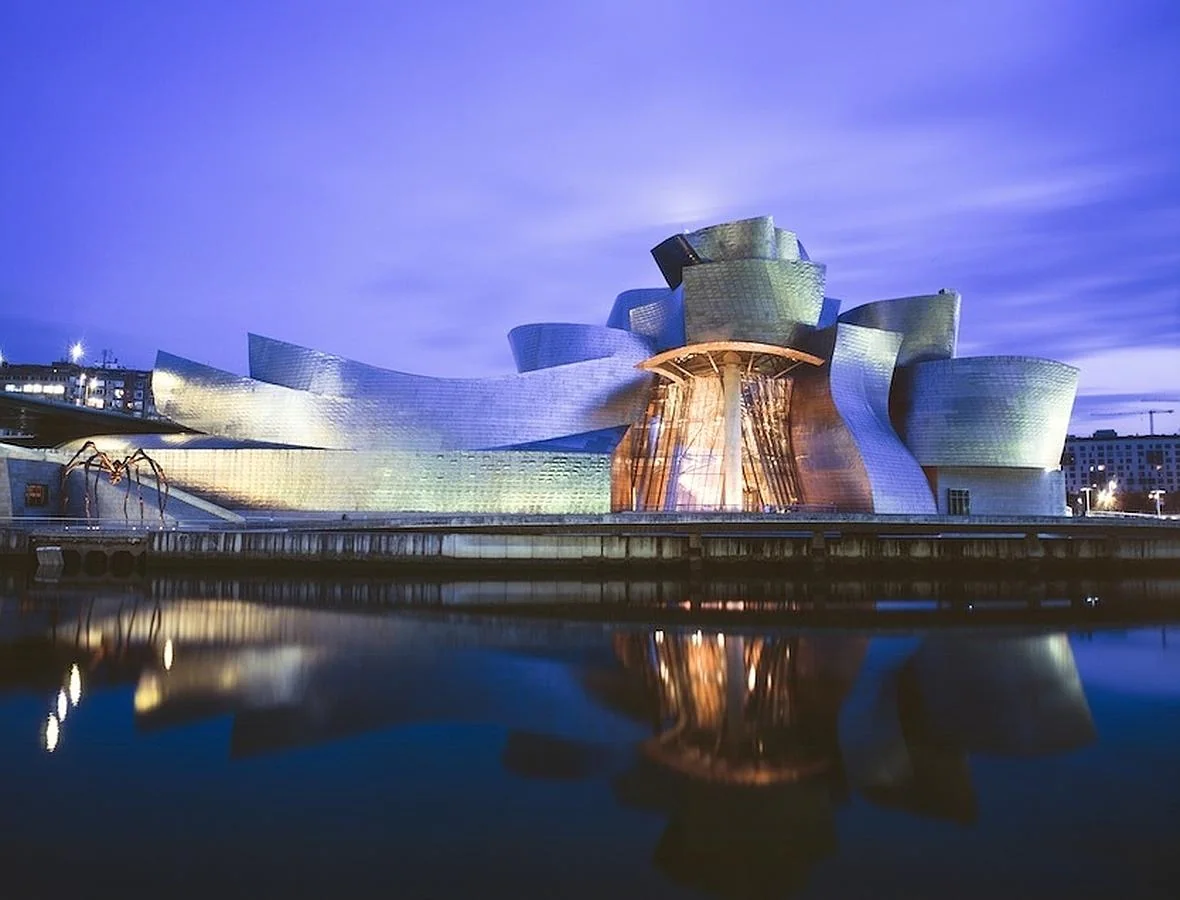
left=894, top=356, right=1077, bottom=469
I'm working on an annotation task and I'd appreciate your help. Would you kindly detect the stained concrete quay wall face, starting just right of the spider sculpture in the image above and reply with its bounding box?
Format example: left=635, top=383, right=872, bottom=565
left=148, top=528, right=1180, bottom=566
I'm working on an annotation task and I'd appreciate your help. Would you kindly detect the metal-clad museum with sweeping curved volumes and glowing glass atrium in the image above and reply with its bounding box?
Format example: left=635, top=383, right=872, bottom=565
left=6, top=216, right=1077, bottom=515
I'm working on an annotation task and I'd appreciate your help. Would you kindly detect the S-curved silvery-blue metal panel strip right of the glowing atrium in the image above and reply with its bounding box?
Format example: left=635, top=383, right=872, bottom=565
left=830, top=323, right=937, bottom=513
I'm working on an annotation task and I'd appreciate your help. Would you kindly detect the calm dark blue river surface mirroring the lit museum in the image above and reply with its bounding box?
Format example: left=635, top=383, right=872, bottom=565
left=0, top=587, right=1180, bottom=899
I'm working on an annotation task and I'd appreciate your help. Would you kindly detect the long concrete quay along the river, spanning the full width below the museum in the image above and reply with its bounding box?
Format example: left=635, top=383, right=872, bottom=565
left=0, top=514, right=1180, bottom=571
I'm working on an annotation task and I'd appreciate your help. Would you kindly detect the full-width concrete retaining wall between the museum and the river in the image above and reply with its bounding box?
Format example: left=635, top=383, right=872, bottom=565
left=0, top=520, right=1180, bottom=570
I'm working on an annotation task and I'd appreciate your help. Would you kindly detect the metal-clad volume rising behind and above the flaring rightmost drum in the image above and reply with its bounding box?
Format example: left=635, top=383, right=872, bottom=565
left=839, top=290, right=962, bottom=366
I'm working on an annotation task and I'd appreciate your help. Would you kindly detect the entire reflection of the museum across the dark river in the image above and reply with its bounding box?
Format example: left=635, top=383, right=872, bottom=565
left=0, top=599, right=1161, bottom=896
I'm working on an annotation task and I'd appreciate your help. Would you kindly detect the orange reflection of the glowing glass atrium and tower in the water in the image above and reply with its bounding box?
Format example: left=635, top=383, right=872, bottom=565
left=599, top=631, right=867, bottom=896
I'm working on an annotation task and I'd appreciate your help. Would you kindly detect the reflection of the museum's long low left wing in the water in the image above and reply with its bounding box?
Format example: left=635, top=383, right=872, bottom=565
left=92, top=602, right=640, bottom=770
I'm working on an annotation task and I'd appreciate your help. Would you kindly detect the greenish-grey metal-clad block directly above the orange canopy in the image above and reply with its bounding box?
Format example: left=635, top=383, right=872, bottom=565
left=684, top=260, right=824, bottom=346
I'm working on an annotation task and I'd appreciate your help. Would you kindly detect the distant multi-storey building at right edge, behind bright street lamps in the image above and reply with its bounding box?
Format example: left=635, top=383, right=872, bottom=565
left=1061, top=431, right=1180, bottom=500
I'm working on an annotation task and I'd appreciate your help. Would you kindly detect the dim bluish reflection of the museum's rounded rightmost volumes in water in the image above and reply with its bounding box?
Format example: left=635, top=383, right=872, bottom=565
left=840, top=635, right=1095, bottom=821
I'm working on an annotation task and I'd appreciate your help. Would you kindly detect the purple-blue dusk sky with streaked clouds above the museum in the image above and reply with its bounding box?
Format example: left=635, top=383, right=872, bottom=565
left=0, top=0, right=1180, bottom=433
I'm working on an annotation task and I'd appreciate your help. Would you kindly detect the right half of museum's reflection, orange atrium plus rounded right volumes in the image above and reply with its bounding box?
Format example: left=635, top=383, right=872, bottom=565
left=594, top=631, right=1094, bottom=896
